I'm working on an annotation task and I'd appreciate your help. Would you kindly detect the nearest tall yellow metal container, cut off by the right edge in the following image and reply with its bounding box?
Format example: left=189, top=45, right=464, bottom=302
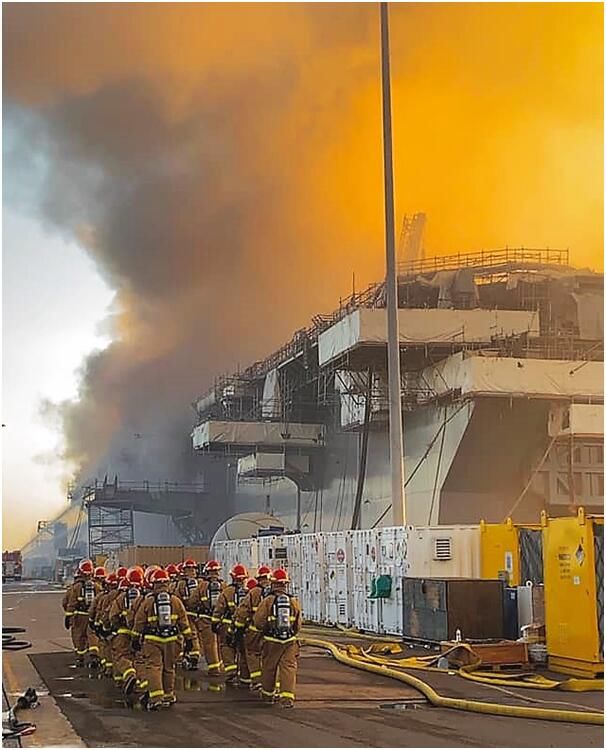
left=541, top=508, right=604, bottom=677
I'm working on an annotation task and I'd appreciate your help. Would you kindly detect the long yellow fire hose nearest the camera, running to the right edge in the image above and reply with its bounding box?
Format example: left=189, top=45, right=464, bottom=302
left=301, top=637, right=604, bottom=725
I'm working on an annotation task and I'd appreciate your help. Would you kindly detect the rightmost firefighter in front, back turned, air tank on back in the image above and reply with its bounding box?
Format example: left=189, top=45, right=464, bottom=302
left=253, top=568, right=302, bottom=708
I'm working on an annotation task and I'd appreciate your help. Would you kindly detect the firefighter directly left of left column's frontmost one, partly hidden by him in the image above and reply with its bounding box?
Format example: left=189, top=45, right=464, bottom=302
left=109, top=568, right=143, bottom=696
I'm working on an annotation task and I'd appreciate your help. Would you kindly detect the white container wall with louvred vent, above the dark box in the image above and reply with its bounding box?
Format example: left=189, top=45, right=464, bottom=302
left=406, top=525, right=481, bottom=578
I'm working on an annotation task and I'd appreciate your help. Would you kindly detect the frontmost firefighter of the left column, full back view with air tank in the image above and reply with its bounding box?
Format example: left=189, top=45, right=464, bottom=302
left=133, top=570, right=192, bottom=711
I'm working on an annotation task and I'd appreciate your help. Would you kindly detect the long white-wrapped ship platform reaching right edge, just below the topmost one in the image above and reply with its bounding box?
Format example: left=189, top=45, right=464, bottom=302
left=421, top=352, right=604, bottom=401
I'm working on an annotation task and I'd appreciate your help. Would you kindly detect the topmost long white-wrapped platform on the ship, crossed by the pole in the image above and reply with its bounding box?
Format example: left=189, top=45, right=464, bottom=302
left=318, top=309, right=539, bottom=366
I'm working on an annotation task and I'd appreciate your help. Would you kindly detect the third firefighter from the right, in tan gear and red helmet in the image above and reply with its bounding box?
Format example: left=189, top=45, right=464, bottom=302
left=211, top=563, right=250, bottom=684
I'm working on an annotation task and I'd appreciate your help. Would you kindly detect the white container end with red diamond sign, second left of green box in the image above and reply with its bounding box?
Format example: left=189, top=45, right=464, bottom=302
left=324, top=531, right=351, bottom=625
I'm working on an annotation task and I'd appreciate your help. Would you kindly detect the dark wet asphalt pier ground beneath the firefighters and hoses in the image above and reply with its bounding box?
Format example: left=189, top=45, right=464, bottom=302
left=3, top=583, right=604, bottom=747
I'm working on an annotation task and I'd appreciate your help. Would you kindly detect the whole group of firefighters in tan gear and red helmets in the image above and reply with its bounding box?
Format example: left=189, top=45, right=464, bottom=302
left=63, top=559, right=302, bottom=711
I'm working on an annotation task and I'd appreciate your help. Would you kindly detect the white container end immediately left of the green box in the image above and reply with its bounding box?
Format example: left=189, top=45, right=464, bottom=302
left=349, top=529, right=379, bottom=633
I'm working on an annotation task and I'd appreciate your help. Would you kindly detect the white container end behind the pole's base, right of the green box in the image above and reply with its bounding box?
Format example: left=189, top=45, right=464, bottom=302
left=377, top=526, right=409, bottom=635
